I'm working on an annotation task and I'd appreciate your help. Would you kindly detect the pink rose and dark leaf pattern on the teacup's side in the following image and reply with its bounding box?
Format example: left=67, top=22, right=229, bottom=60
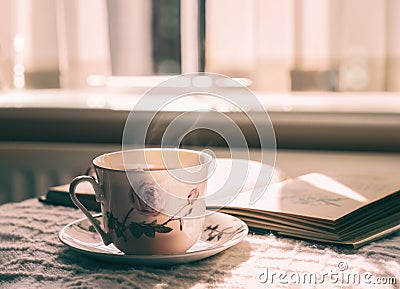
left=106, top=182, right=200, bottom=242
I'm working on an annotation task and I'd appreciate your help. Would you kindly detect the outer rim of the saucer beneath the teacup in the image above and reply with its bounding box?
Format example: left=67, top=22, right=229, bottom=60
left=58, top=210, right=249, bottom=265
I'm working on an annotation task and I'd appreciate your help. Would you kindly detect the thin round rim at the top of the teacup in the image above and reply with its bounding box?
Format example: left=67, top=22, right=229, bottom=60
left=92, top=148, right=214, bottom=173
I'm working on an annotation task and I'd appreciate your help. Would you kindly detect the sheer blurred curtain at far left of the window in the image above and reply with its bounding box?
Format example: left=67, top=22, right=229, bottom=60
left=0, top=0, right=110, bottom=88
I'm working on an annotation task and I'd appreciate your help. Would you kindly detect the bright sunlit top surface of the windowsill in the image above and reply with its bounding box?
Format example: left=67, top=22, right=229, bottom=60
left=0, top=89, right=400, bottom=114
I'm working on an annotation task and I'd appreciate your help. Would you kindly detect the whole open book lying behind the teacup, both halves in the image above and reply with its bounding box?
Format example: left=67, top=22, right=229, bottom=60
left=39, top=159, right=400, bottom=247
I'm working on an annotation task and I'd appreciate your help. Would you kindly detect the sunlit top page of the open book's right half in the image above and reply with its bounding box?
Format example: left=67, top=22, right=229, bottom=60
left=207, top=173, right=400, bottom=220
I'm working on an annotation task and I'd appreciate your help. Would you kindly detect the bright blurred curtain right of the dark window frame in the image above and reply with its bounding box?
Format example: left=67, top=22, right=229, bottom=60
left=206, top=0, right=400, bottom=91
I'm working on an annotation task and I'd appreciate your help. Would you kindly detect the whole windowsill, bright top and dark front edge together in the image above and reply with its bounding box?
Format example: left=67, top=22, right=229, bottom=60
left=0, top=90, right=400, bottom=151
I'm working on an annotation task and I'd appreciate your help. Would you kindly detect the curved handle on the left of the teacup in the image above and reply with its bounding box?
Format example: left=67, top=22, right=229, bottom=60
left=69, top=176, right=112, bottom=245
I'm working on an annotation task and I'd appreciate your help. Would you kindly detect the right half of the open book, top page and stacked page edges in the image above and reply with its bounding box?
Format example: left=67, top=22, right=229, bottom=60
left=207, top=173, right=400, bottom=248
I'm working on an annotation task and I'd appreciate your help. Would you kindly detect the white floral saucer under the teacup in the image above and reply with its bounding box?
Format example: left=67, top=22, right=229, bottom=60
left=58, top=212, right=248, bottom=266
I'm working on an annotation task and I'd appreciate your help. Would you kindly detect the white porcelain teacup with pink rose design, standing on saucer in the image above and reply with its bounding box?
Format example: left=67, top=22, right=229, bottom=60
left=69, top=148, right=213, bottom=254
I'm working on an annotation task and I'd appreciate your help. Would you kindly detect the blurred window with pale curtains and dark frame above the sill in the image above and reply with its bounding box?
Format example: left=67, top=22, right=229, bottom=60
left=0, top=0, right=400, bottom=92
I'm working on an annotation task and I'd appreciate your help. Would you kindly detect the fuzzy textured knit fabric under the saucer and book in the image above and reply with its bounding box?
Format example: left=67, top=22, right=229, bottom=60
left=0, top=199, right=400, bottom=289
